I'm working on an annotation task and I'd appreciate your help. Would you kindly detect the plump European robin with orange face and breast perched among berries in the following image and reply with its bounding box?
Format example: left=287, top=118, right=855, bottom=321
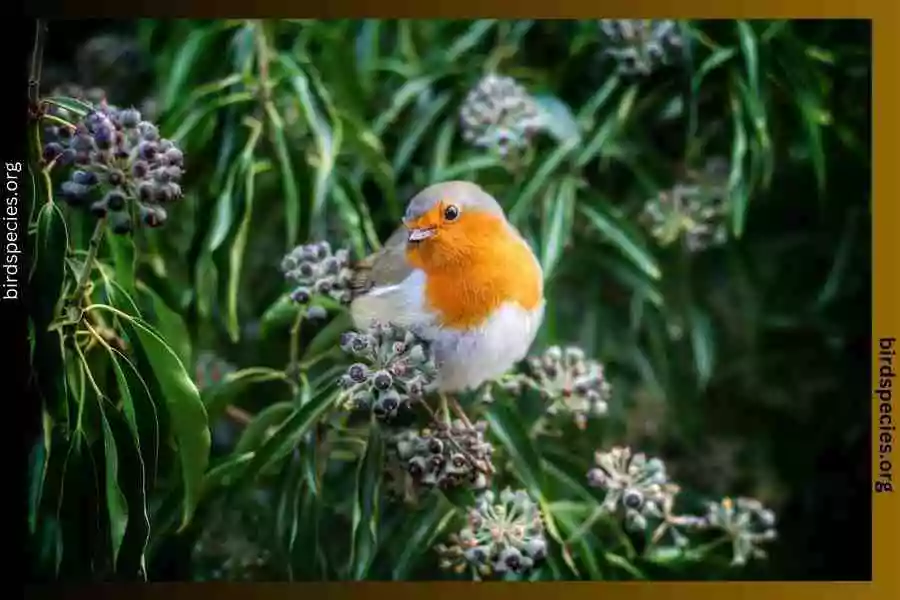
left=350, top=181, right=545, bottom=393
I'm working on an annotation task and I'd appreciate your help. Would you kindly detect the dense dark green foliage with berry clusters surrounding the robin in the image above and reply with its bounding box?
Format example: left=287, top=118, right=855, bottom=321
left=29, top=20, right=870, bottom=580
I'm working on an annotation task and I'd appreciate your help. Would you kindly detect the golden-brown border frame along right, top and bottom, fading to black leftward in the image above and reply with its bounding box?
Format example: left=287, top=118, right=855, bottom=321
left=26, top=0, right=900, bottom=600
